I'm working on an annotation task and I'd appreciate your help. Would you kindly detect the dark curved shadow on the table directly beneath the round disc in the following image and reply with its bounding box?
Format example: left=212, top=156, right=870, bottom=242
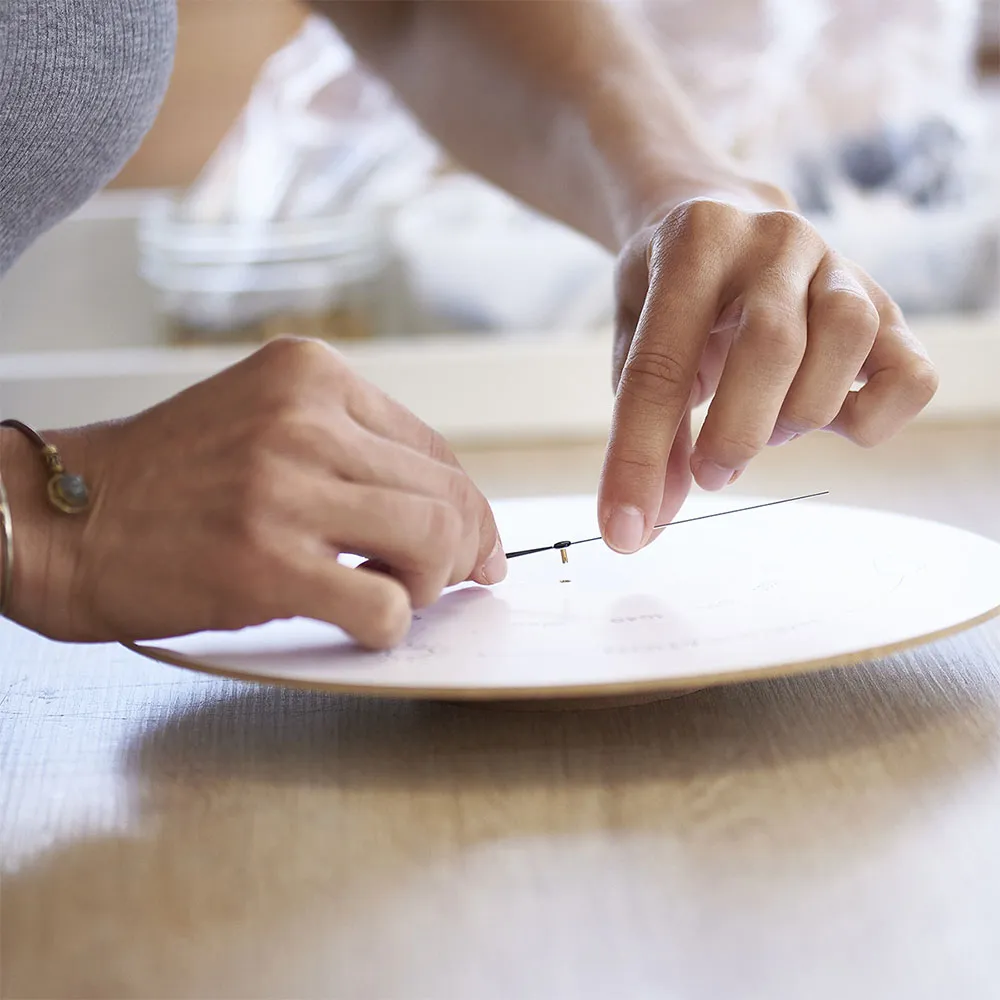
left=125, top=624, right=997, bottom=796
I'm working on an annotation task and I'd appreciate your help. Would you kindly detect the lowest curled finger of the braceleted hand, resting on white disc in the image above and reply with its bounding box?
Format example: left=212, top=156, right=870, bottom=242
left=274, top=555, right=413, bottom=649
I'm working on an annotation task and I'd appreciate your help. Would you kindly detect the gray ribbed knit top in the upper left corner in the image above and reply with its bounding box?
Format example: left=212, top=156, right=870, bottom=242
left=0, top=0, right=176, bottom=276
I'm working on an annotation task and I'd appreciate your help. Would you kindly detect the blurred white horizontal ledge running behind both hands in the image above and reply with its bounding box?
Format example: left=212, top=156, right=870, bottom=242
left=0, top=316, right=1000, bottom=443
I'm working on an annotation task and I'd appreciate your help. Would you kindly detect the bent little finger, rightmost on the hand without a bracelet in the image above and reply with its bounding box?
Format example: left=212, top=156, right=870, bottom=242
left=829, top=283, right=938, bottom=448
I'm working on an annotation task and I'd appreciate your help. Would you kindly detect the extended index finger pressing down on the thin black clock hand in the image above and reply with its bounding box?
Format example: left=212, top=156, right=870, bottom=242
left=598, top=215, right=722, bottom=552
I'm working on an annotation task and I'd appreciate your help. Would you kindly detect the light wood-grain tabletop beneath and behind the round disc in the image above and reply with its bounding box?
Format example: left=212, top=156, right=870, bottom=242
left=0, top=428, right=1000, bottom=1000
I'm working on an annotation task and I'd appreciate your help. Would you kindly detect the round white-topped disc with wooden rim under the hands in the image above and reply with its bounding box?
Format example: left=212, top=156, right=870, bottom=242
left=133, top=495, right=1000, bottom=707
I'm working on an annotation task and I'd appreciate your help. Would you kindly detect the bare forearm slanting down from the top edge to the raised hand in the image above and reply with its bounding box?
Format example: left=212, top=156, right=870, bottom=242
left=314, top=0, right=781, bottom=250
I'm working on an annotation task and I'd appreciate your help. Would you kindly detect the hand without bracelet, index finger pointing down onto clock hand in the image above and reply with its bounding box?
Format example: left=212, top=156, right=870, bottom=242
left=599, top=199, right=937, bottom=552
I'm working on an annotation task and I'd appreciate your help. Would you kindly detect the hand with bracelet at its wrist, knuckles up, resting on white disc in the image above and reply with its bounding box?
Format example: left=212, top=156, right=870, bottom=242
left=3, top=339, right=506, bottom=648
